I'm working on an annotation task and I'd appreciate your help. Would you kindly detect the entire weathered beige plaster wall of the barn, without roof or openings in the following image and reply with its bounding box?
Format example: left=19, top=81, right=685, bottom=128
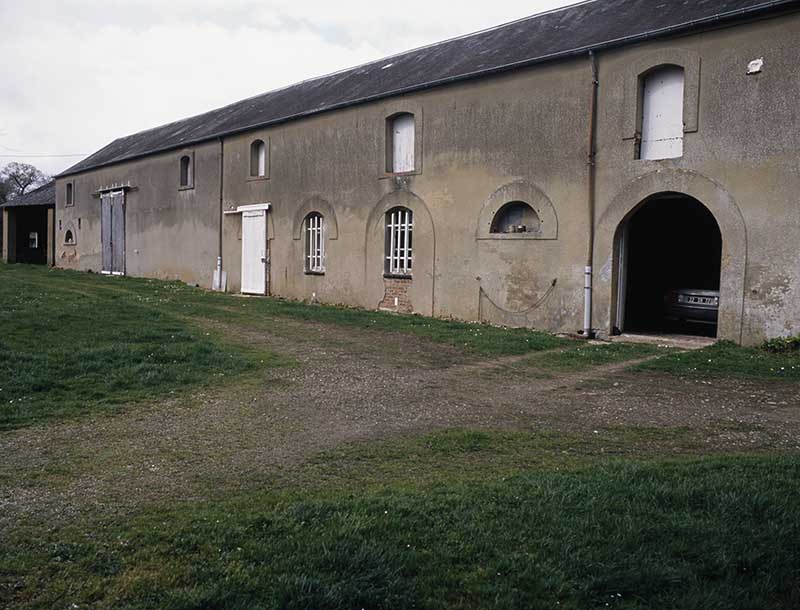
left=57, top=10, right=800, bottom=343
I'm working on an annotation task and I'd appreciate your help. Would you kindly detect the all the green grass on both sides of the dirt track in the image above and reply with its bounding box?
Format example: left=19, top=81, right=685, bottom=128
left=0, top=265, right=800, bottom=610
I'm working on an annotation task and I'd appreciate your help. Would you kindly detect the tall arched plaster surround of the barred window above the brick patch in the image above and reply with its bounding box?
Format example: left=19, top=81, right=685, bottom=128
left=364, top=190, right=436, bottom=315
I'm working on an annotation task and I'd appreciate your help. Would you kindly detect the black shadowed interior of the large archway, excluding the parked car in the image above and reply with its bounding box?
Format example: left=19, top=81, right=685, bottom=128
left=625, top=194, right=722, bottom=337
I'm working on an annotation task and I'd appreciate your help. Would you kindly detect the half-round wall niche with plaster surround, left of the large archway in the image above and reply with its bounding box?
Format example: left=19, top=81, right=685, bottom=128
left=476, top=180, right=558, bottom=239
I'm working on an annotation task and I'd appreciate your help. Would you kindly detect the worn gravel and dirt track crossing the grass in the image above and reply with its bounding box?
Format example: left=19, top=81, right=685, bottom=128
left=0, top=319, right=800, bottom=535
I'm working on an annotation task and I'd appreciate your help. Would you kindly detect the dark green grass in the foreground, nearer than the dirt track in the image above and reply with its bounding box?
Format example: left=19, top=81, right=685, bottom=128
left=6, top=448, right=800, bottom=610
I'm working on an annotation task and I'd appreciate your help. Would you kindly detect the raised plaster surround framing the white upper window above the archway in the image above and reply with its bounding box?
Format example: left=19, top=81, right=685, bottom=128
left=622, top=48, right=700, bottom=140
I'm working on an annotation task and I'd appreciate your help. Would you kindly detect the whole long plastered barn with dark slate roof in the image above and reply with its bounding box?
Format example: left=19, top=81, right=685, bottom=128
left=55, top=0, right=800, bottom=344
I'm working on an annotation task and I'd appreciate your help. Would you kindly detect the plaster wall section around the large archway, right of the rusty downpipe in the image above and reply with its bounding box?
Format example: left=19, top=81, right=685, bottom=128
left=595, top=14, right=800, bottom=344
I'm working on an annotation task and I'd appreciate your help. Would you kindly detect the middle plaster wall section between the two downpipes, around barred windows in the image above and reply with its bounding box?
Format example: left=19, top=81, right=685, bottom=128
left=224, top=60, right=589, bottom=330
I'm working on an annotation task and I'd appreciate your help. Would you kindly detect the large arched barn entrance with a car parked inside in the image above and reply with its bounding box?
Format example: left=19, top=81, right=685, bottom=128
left=617, top=193, right=722, bottom=337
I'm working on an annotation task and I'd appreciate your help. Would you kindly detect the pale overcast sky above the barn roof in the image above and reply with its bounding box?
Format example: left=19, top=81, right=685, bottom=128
left=0, top=0, right=575, bottom=174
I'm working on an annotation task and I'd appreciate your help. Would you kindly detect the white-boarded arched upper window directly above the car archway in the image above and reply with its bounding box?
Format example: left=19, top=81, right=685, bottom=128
left=639, top=66, right=684, bottom=160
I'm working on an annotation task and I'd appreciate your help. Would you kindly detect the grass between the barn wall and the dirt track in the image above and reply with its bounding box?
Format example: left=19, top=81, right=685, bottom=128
left=0, top=264, right=800, bottom=430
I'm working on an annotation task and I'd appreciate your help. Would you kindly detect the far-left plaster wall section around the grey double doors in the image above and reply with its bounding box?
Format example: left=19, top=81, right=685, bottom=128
left=56, top=143, right=219, bottom=287
